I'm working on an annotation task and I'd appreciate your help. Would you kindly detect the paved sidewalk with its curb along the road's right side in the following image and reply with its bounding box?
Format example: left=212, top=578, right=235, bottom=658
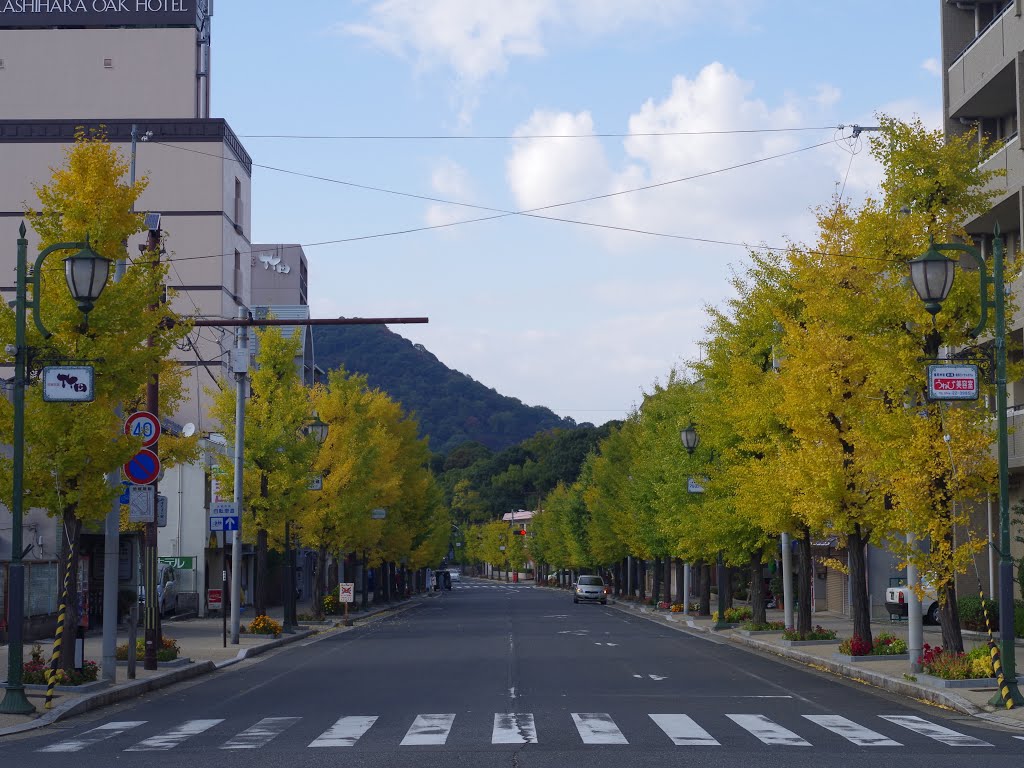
left=609, top=600, right=1024, bottom=732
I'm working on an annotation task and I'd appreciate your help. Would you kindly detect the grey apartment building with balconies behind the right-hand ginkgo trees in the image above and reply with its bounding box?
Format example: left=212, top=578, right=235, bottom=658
left=940, top=0, right=1024, bottom=591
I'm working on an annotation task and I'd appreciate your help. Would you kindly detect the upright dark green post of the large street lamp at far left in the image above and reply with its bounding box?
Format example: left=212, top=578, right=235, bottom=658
left=0, top=222, right=38, bottom=715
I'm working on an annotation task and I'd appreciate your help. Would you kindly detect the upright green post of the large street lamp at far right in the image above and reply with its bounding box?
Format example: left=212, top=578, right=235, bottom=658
left=982, top=230, right=1024, bottom=705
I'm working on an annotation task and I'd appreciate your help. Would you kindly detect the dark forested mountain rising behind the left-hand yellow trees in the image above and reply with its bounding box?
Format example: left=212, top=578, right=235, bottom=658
left=313, top=326, right=577, bottom=454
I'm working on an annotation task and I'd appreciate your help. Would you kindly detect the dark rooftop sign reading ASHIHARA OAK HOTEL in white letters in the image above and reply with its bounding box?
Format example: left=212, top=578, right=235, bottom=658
left=0, top=0, right=207, bottom=28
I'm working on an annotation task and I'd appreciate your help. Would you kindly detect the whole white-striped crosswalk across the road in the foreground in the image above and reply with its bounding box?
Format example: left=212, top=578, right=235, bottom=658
left=37, top=712, right=993, bottom=753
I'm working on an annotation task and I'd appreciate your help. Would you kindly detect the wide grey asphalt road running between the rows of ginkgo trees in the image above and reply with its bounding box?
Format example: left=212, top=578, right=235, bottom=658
left=0, top=580, right=1024, bottom=768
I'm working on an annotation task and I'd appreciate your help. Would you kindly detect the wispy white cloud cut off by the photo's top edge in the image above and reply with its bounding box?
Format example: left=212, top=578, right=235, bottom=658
left=333, top=0, right=733, bottom=122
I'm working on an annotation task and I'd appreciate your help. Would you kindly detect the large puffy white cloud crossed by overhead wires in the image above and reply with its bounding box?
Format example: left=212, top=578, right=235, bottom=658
left=506, top=63, right=831, bottom=252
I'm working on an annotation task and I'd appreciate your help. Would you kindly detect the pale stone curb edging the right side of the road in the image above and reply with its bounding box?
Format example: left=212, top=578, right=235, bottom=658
left=609, top=601, right=1024, bottom=730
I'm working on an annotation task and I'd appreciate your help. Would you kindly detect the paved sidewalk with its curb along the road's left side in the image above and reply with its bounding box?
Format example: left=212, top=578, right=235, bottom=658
left=0, top=593, right=432, bottom=736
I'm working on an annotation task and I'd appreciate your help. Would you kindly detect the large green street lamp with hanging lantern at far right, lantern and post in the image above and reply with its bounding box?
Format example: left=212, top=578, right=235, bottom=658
left=909, top=226, right=1024, bottom=705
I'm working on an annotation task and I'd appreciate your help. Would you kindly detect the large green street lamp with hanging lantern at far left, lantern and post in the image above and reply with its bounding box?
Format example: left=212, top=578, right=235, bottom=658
left=0, top=222, right=112, bottom=715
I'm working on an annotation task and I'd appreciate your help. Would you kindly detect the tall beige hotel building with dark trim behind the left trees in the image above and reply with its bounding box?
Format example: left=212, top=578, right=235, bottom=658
left=0, top=0, right=252, bottom=616
